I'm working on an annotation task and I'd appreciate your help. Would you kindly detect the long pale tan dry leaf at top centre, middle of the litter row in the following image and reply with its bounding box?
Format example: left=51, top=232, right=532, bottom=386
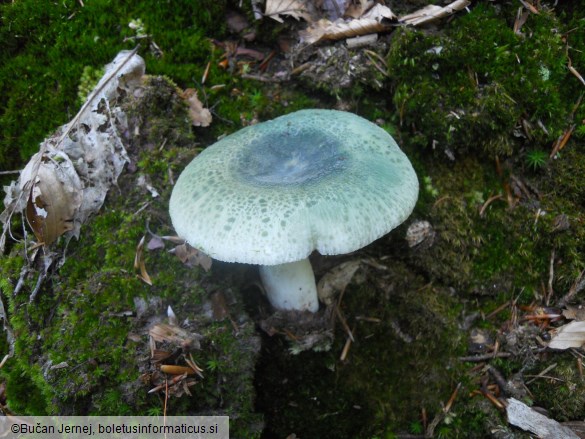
left=299, top=4, right=396, bottom=44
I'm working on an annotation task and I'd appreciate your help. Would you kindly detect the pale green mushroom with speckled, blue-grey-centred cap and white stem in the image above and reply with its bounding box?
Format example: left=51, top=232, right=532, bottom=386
left=169, top=110, right=418, bottom=312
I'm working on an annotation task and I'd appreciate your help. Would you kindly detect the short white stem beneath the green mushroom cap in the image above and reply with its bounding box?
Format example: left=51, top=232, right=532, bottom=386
left=260, top=259, right=319, bottom=312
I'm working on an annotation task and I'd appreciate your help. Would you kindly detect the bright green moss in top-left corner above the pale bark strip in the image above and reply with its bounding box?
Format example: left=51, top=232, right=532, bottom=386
left=0, top=0, right=226, bottom=175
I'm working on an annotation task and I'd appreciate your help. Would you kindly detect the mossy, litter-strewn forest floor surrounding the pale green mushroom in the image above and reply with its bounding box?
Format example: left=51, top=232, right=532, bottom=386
left=0, top=0, right=585, bottom=438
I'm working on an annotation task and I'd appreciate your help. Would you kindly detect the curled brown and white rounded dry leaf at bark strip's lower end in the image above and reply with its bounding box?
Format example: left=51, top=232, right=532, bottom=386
left=20, top=151, right=82, bottom=246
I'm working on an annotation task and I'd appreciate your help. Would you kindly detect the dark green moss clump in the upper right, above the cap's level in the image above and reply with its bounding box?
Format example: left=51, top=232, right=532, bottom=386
left=387, top=3, right=577, bottom=157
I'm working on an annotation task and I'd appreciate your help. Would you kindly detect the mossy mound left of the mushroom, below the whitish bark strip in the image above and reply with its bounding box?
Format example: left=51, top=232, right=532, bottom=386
left=0, top=77, right=261, bottom=437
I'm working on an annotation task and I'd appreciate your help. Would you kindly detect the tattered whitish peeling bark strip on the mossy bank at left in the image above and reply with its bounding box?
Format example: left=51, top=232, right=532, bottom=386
left=0, top=49, right=145, bottom=252
